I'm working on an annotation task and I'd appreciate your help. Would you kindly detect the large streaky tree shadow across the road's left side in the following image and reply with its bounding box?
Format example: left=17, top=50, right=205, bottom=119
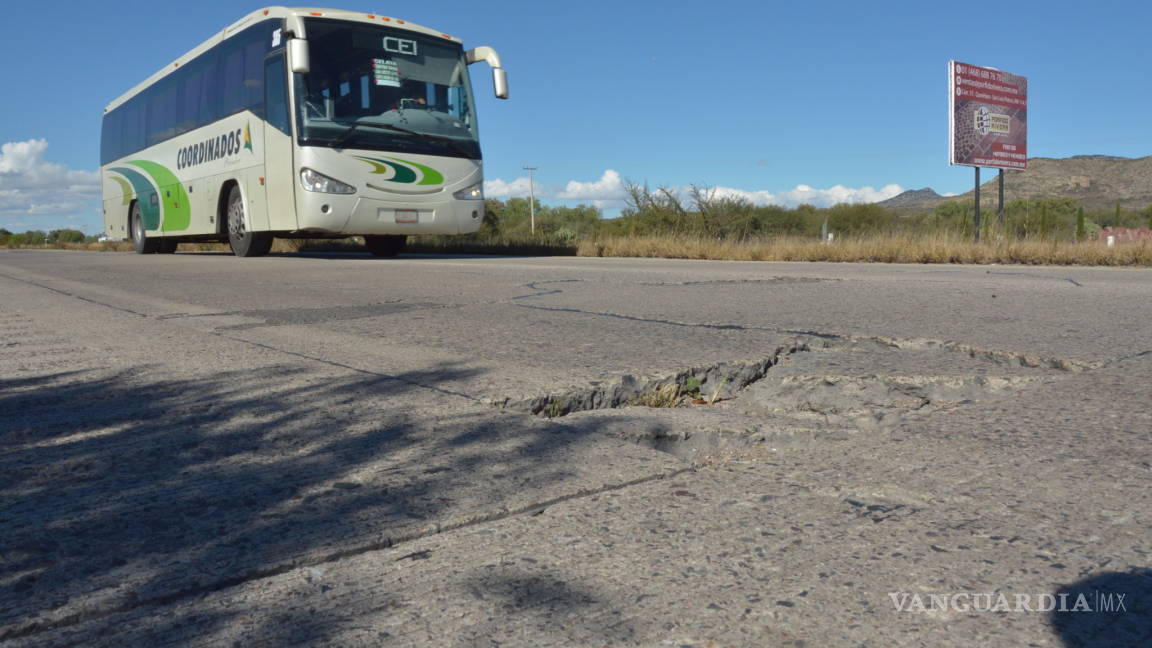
left=0, top=366, right=654, bottom=643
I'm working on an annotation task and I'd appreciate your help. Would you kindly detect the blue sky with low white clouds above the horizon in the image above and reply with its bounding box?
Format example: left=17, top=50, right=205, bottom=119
left=0, top=0, right=1152, bottom=233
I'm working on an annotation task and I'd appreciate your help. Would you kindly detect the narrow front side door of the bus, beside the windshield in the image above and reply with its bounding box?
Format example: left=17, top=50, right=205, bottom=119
left=264, top=52, right=296, bottom=232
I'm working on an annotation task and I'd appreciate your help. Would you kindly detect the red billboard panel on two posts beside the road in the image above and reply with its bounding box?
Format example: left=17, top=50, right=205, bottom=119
left=948, top=61, right=1028, bottom=168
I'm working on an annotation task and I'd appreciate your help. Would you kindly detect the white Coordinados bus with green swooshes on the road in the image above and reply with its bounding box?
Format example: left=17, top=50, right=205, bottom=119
left=100, top=7, right=508, bottom=256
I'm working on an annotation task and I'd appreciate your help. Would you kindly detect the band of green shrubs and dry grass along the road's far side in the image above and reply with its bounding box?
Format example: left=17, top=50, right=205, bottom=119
left=0, top=179, right=1152, bottom=265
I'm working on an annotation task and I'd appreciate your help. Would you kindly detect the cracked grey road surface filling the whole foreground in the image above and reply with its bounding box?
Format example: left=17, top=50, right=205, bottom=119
left=0, top=250, right=1152, bottom=648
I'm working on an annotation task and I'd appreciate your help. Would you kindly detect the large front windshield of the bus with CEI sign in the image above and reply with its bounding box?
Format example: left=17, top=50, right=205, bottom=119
left=295, top=20, right=480, bottom=159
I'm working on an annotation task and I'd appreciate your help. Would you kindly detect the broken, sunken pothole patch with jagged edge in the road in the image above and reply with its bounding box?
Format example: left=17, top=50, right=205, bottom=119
left=498, top=339, right=1063, bottom=461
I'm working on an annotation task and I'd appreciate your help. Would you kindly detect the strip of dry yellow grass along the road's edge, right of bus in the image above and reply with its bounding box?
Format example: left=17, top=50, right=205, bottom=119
left=577, top=234, right=1152, bottom=265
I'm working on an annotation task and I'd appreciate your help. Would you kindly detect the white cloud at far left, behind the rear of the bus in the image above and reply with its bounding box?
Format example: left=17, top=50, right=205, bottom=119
left=0, top=140, right=100, bottom=216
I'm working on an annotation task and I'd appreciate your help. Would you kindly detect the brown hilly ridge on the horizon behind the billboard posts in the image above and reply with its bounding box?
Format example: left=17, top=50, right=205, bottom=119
left=879, top=155, right=1152, bottom=213
